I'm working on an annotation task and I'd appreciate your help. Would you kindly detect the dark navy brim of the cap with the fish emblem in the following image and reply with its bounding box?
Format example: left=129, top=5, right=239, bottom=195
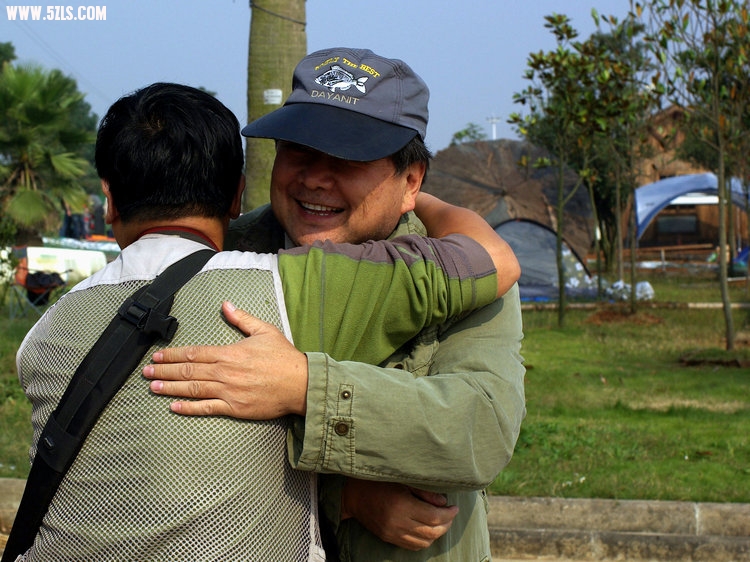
left=242, top=103, right=418, bottom=162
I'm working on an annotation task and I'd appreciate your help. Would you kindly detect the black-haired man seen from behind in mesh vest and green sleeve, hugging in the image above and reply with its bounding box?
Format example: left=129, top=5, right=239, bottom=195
left=17, top=83, right=517, bottom=561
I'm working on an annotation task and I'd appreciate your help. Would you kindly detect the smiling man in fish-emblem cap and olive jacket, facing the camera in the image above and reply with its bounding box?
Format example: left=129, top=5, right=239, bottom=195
left=154, top=48, right=525, bottom=562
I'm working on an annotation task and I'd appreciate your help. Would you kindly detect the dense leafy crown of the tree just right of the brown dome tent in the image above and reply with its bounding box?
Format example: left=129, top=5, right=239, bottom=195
left=511, top=10, right=661, bottom=298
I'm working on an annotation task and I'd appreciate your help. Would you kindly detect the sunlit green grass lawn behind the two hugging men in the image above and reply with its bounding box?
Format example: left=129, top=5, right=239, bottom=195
left=0, top=264, right=750, bottom=502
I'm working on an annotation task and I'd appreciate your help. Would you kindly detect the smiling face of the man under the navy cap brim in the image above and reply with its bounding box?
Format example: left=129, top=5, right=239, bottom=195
left=271, top=141, right=425, bottom=245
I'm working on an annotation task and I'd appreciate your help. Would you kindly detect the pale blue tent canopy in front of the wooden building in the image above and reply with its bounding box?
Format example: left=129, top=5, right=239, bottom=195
left=635, top=174, right=748, bottom=238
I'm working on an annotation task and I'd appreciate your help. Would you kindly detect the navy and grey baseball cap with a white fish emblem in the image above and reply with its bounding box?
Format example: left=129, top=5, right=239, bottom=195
left=242, top=48, right=430, bottom=162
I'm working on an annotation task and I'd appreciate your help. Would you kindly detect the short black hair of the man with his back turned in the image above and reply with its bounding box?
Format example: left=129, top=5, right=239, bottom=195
left=95, top=83, right=244, bottom=222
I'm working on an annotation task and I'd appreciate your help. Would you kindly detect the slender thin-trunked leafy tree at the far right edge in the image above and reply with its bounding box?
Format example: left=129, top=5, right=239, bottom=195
left=636, top=0, right=750, bottom=350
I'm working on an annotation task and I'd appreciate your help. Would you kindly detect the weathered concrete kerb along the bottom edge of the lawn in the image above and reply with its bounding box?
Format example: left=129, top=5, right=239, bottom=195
left=0, top=478, right=750, bottom=562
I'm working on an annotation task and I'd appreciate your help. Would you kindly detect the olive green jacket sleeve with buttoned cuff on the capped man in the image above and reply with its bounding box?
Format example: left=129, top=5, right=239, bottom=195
left=290, top=290, right=525, bottom=492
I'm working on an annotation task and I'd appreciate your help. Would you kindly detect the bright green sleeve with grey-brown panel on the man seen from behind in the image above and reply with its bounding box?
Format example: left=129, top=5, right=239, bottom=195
left=279, top=236, right=497, bottom=364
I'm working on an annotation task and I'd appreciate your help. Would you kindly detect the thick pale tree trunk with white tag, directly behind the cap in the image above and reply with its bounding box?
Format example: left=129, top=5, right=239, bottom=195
left=243, top=0, right=307, bottom=210
